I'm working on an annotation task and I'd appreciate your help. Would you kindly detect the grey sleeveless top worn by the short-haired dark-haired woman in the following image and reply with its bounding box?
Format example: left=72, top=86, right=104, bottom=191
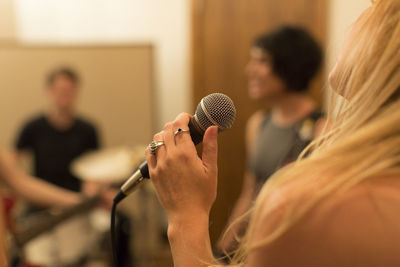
left=248, top=112, right=321, bottom=190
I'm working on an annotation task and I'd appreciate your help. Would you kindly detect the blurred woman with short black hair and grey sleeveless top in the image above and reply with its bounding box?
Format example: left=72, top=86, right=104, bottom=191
left=219, top=26, right=323, bottom=260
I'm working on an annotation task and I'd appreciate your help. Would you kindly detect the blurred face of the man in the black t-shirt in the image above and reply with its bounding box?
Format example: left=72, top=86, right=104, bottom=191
left=47, top=75, right=78, bottom=111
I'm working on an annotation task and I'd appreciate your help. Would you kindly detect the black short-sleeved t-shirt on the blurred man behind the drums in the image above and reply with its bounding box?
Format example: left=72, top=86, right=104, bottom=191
left=15, top=115, right=99, bottom=191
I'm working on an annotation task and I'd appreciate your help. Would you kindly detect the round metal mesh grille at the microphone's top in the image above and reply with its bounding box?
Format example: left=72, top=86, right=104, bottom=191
left=195, top=93, right=236, bottom=131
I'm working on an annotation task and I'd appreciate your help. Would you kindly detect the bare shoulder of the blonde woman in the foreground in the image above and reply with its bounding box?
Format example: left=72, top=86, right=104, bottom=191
left=249, top=177, right=400, bottom=267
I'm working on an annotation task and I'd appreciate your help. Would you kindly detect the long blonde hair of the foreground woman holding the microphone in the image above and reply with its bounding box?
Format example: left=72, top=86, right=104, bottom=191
left=223, top=0, right=400, bottom=266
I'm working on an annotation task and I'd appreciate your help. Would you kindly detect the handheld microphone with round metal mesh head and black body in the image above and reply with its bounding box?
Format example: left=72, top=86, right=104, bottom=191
left=114, top=93, right=236, bottom=203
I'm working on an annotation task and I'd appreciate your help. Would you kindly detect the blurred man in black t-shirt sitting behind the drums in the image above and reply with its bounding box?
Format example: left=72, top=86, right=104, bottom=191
left=15, top=67, right=99, bottom=196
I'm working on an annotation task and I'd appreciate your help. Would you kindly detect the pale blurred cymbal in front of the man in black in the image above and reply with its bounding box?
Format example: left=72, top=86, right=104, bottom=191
left=71, top=145, right=145, bottom=182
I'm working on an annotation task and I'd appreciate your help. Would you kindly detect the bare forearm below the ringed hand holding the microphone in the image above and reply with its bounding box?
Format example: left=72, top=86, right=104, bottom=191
left=168, top=213, right=215, bottom=267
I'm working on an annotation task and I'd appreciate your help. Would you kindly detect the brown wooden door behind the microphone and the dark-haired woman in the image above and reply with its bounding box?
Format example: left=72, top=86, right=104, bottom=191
left=192, top=0, right=327, bottom=245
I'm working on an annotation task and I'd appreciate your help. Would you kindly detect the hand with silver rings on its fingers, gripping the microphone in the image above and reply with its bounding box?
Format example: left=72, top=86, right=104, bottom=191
left=146, top=113, right=218, bottom=217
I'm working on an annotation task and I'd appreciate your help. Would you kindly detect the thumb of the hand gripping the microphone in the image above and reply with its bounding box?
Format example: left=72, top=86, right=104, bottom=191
left=202, top=126, right=218, bottom=172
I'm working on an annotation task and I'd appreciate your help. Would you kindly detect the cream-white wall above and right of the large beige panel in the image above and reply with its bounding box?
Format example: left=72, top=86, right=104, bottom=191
left=15, top=0, right=192, bottom=130
